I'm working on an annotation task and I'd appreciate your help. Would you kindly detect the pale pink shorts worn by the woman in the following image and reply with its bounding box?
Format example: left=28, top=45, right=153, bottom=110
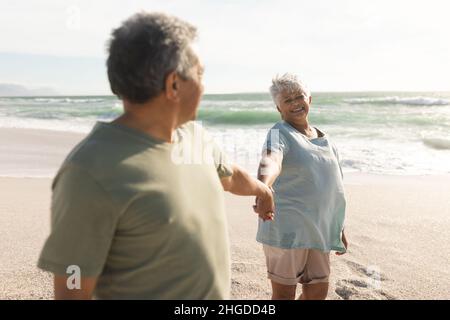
left=263, top=244, right=330, bottom=285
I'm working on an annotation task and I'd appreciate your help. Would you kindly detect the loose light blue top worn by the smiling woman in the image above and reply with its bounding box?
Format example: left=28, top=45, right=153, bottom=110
left=256, top=121, right=346, bottom=252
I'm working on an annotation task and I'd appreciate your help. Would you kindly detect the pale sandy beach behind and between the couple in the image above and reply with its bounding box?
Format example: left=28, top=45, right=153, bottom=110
left=0, top=129, right=450, bottom=299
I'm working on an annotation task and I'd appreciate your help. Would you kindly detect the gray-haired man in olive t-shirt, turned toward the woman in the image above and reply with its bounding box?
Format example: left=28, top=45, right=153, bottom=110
left=38, top=13, right=273, bottom=299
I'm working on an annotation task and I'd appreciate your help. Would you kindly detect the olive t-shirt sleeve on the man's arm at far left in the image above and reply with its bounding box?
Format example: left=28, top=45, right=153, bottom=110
left=38, top=164, right=118, bottom=277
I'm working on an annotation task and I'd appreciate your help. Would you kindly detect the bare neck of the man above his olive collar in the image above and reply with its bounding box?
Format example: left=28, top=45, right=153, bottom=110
left=113, top=100, right=180, bottom=142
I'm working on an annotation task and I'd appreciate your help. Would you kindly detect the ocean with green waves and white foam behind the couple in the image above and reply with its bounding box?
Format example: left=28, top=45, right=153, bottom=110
left=0, top=92, right=450, bottom=175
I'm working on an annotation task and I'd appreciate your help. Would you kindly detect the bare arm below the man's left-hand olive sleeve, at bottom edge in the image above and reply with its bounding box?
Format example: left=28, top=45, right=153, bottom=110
left=53, top=275, right=97, bottom=300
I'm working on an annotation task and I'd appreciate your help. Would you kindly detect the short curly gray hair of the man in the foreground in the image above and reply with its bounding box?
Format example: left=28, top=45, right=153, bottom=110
left=107, top=12, right=198, bottom=103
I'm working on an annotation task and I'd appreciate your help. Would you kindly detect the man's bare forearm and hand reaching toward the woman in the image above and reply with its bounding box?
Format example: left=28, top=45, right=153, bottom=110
left=220, top=165, right=274, bottom=220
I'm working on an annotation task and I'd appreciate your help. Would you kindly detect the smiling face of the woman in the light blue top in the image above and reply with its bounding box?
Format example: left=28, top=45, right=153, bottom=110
left=277, top=91, right=311, bottom=123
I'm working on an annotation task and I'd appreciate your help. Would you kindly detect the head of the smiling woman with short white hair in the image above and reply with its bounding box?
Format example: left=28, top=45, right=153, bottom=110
left=270, top=73, right=312, bottom=123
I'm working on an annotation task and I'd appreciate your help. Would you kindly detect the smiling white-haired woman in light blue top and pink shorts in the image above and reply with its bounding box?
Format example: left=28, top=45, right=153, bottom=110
left=255, top=74, right=347, bottom=300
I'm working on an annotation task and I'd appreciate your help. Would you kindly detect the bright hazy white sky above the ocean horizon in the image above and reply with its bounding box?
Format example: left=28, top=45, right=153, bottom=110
left=0, top=0, right=450, bottom=95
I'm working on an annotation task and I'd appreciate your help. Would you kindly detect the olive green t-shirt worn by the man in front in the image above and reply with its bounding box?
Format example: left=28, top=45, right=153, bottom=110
left=38, top=122, right=232, bottom=299
